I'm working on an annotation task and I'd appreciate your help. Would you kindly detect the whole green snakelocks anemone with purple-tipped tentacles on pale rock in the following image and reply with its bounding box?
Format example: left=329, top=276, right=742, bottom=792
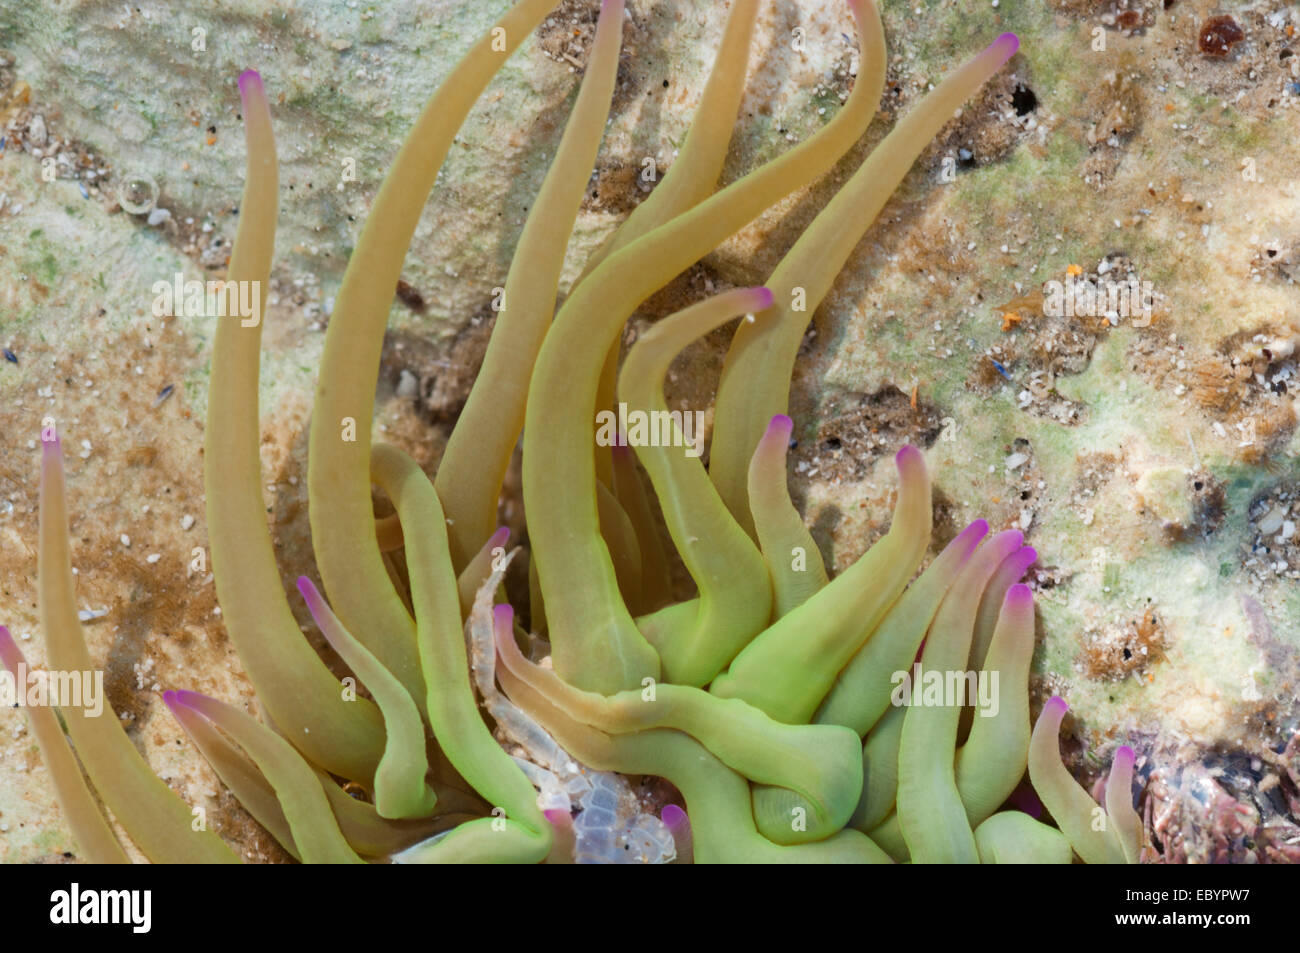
left=0, top=0, right=1141, bottom=863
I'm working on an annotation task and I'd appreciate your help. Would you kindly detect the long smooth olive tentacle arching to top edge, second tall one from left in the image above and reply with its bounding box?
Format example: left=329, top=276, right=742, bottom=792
left=307, top=0, right=569, bottom=707
